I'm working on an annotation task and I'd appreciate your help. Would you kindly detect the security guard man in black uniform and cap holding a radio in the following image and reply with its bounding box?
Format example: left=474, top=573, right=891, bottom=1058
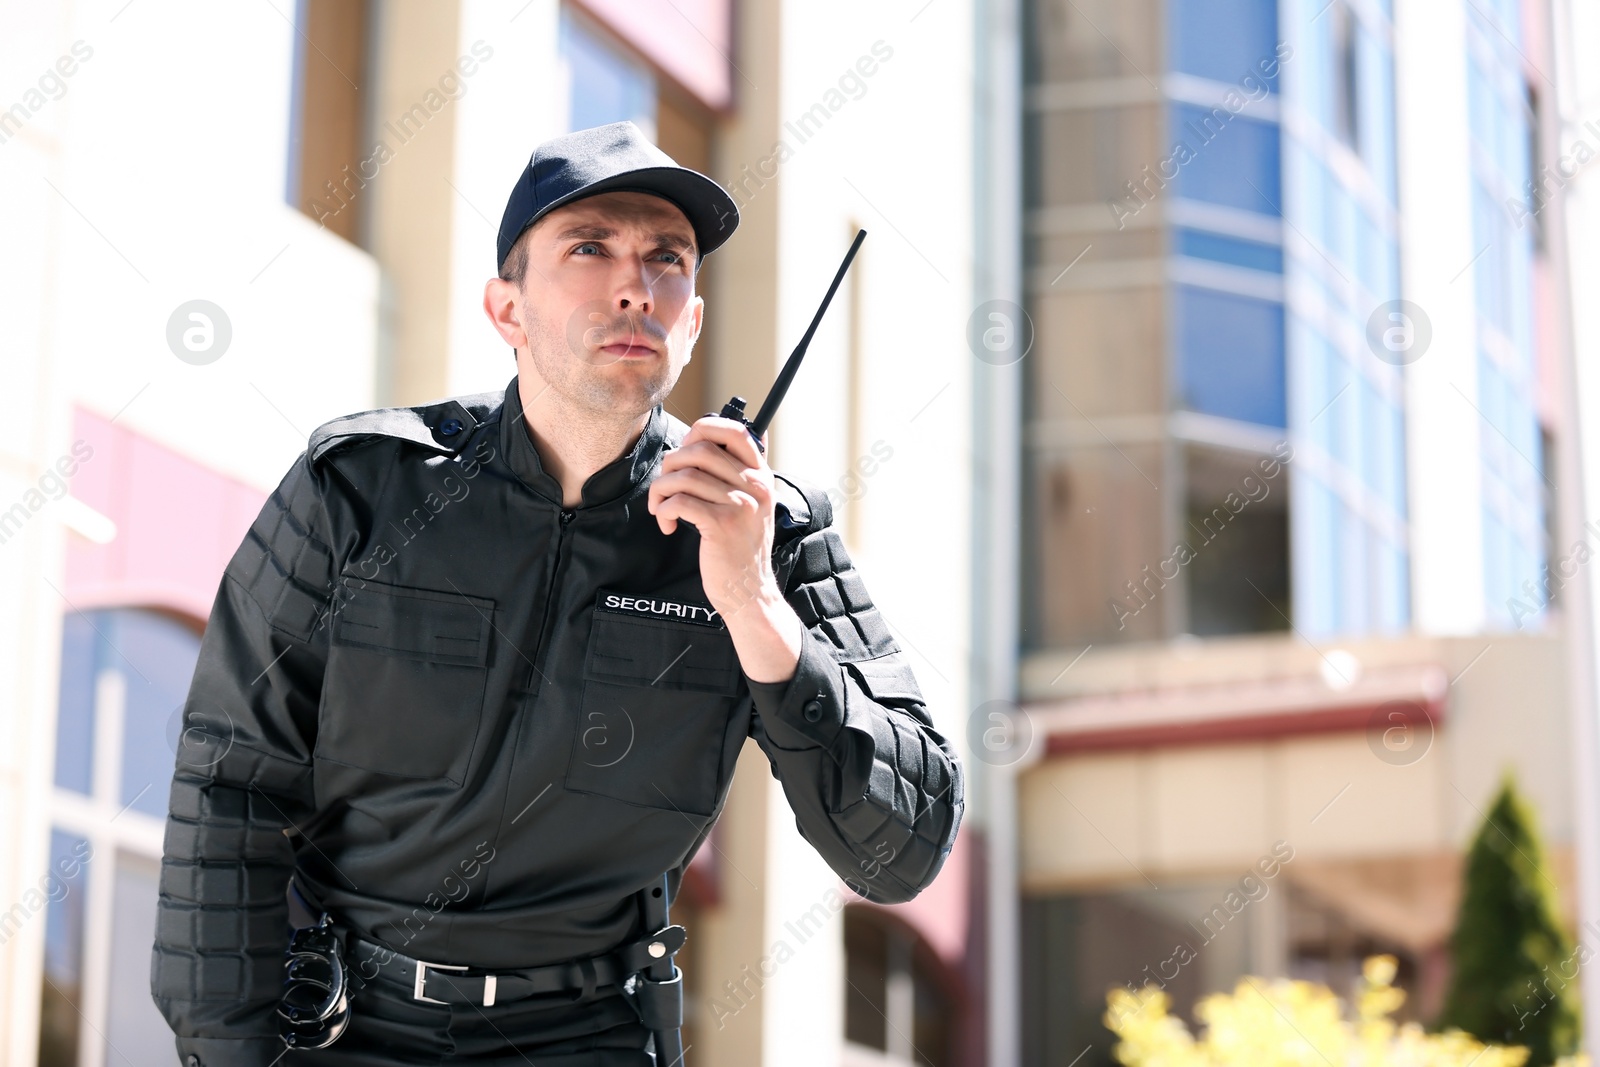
left=152, top=123, right=963, bottom=1067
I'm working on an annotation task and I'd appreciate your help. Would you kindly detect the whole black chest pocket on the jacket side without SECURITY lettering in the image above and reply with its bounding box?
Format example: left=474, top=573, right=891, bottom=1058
left=315, top=582, right=494, bottom=785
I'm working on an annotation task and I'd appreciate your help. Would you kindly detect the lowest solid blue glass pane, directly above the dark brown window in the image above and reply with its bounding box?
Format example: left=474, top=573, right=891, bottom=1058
left=1174, top=285, right=1285, bottom=426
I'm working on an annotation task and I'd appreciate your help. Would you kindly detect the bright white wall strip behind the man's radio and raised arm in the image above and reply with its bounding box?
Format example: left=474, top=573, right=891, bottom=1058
left=758, top=2, right=982, bottom=1065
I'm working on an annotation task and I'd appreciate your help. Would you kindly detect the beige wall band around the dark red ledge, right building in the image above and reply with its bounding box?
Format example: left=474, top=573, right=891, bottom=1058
left=1018, top=635, right=1573, bottom=893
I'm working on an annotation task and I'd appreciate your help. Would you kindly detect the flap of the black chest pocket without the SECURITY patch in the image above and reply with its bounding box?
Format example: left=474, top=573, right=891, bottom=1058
left=333, top=579, right=494, bottom=667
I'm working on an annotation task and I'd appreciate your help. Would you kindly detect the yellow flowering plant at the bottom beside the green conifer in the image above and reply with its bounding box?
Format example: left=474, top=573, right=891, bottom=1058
left=1104, top=957, right=1589, bottom=1067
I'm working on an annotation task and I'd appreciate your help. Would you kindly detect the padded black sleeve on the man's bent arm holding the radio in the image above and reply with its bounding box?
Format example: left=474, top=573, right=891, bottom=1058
left=747, top=512, right=965, bottom=904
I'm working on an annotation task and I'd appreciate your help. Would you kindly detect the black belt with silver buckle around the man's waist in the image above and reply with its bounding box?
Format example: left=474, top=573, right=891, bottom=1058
left=347, top=926, right=686, bottom=1008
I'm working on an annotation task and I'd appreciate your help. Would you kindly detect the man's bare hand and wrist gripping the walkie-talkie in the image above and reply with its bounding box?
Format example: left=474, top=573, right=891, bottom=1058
left=650, top=414, right=805, bottom=681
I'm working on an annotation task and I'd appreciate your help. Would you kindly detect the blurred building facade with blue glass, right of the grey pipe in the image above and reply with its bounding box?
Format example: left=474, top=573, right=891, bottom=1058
left=1011, top=0, right=1576, bottom=1064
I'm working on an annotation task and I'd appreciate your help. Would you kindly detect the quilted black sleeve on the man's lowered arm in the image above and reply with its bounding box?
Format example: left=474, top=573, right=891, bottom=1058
left=150, top=454, right=338, bottom=1065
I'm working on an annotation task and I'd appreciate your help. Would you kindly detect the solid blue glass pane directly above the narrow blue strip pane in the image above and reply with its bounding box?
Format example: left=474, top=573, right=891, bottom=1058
left=1170, top=104, right=1283, bottom=216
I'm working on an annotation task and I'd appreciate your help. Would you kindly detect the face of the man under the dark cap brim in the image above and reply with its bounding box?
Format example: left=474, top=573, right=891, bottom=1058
left=517, top=192, right=704, bottom=418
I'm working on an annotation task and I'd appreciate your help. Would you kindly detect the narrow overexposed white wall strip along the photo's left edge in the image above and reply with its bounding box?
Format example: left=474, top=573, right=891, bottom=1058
left=0, top=0, right=77, bottom=1062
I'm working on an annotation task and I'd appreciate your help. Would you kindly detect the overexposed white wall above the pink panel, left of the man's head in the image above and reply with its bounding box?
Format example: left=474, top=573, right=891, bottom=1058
left=51, top=0, right=378, bottom=488
